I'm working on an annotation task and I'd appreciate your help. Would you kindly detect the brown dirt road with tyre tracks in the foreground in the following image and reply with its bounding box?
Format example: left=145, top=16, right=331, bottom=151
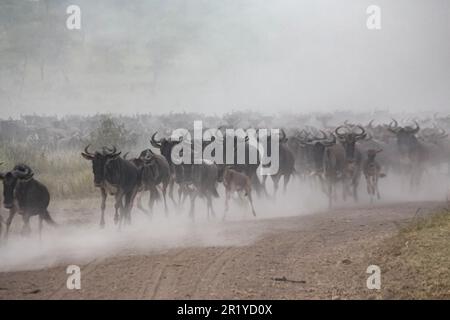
left=0, top=202, right=442, bottom=299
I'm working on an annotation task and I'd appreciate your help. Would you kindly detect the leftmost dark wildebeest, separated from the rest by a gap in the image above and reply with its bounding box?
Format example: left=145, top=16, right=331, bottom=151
left=0, top=164, right=56, bottom=238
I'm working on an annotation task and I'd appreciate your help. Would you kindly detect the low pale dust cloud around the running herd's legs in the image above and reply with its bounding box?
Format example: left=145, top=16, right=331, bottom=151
left=0, top=168, right=450, bottom=272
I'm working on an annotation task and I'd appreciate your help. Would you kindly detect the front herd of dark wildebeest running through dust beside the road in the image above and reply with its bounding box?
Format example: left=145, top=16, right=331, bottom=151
left=0, top=119, right=450, bottom=237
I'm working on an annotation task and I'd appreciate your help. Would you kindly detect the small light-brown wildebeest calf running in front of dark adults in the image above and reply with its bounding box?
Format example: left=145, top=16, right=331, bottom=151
left=221, top=166, right=256, bottom=219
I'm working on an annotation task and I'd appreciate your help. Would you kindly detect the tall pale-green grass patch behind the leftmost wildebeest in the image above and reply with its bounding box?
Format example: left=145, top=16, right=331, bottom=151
left=0, top=143, right=97, bottom=199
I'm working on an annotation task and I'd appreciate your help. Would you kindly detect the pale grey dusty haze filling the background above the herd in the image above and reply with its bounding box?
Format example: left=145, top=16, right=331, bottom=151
left=0, top=0, right=450, bottom=117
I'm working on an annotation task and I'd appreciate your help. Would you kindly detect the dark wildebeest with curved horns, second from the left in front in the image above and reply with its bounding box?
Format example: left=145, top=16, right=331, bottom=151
left=81, top=146, right=140, bottom=227
